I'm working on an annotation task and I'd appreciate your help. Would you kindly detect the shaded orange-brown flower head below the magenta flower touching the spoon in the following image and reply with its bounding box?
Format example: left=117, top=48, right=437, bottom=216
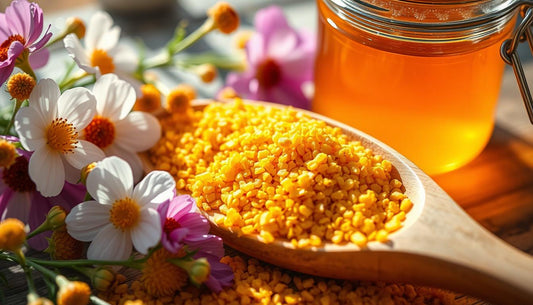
left=141, top=248, right=189, bottom=297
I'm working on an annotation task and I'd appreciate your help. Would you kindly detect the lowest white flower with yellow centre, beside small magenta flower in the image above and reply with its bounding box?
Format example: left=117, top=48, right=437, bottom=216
left=66, top=157, right=176, bottom=260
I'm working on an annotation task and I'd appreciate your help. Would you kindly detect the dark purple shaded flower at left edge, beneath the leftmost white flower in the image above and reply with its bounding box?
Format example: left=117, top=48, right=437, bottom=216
left=0, top=137, right=86, bottom=250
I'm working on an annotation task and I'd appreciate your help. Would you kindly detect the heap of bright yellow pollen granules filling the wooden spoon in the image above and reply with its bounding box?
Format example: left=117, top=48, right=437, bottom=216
left=149, top=100, right=413, bottom=248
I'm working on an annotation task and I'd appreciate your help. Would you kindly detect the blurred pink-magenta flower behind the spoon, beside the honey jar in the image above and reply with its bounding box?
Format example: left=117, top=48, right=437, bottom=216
left=226, top=6, right=316, bottom=108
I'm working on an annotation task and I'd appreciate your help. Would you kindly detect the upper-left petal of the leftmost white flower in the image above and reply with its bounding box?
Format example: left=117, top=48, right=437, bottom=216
left=29, top=78, right=61, bottom=124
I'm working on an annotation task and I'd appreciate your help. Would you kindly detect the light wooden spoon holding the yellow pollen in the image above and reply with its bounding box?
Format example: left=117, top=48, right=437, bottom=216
left=143, top=100, right=533, bottom=305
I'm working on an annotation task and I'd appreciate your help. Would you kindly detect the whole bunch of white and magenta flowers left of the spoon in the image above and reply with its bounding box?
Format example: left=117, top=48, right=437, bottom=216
left=0, top=0, right=314, bottom=305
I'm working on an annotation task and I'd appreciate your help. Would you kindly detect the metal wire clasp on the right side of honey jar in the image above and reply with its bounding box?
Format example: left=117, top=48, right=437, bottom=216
left=500, top=3, right=533, bottom=124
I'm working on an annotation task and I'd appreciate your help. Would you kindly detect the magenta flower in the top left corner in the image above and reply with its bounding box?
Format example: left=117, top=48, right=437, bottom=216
left=0, top=0, right=52, bottom=84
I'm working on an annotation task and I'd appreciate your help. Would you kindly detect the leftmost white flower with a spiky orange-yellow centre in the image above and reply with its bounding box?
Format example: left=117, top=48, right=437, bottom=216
left=15, top=79, right=105, bottom=197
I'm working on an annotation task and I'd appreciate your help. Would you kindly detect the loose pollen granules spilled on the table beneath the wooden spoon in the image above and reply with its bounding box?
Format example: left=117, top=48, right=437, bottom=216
left=98, top=256, right=456, bottom=305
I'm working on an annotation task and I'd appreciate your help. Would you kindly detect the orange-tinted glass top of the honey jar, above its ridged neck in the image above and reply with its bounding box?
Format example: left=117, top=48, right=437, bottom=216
left=330, top=0, right=527, bottom=30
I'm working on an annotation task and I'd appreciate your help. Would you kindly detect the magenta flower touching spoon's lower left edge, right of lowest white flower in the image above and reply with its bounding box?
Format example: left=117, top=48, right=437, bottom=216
left=157, top=195, right=233, bottom=292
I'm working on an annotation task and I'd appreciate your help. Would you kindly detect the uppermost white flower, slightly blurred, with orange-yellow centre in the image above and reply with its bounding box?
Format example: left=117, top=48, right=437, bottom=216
left=63, top=11, right=140, bottom=86
